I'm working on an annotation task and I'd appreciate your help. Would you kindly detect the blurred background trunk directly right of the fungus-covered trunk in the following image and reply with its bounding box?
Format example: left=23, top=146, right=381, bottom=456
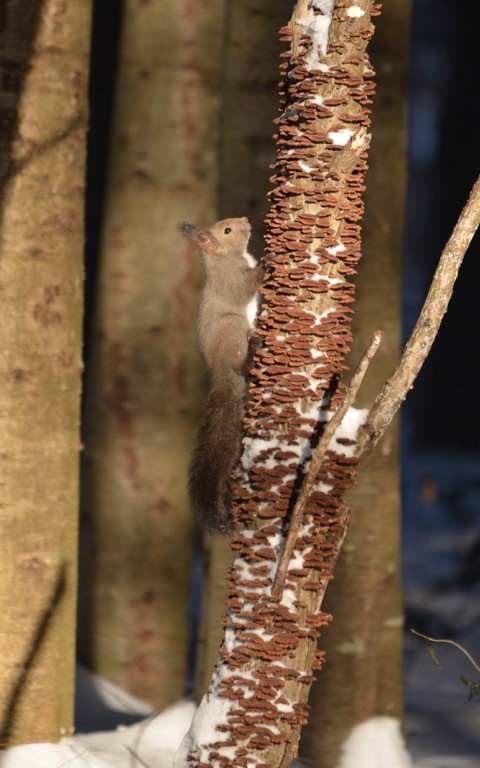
left=300, top=0, right=409, bottom=768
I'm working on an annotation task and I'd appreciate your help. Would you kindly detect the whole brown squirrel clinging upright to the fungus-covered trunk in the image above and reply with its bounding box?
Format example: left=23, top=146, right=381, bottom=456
left=178, top=217, right=263, bottom=534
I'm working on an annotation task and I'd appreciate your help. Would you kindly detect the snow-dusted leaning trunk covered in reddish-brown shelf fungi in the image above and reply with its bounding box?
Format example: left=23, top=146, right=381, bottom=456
left=175, top=0, right=378, bottom=768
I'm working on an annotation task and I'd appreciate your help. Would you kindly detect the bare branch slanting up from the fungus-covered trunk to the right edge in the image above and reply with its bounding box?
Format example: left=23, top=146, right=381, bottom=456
left=356, top=172, right=480, bottom=458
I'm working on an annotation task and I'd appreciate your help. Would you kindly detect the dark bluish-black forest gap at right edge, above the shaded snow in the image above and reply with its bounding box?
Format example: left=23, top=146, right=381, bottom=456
left=402, top=0, right=480, bottom=612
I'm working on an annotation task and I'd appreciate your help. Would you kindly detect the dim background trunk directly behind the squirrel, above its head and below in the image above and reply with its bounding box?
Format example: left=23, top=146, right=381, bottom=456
left=196, top=0, right=292, bottom=699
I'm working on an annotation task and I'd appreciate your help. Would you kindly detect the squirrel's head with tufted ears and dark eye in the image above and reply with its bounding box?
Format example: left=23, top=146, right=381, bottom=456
left=178, top=216, right=251, bottom=258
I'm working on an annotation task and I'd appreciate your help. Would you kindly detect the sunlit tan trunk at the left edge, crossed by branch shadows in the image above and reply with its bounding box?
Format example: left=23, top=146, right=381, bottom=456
left=0, top=0, right=91, bottom=747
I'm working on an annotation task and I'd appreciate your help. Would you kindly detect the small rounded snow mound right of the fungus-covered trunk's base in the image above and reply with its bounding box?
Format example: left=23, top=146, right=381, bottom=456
left=338, top=717, right=412, bottom=768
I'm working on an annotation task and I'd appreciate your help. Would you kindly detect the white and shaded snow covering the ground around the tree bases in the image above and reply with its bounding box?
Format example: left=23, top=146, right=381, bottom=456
left=0, top=656, right=480, bottom=768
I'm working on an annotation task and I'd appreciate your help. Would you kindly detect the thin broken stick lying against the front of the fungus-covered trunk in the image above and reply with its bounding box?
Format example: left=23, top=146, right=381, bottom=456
left=272, top=331, right=383, bottom=598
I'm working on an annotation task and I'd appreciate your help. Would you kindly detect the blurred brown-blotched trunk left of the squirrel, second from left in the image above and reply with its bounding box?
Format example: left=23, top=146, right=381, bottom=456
left=81, top=0, right=223, bottom=708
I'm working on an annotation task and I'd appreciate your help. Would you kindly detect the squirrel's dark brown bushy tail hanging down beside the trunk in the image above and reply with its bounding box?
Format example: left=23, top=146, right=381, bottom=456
left=189, top=377, right=244, bottom=534
